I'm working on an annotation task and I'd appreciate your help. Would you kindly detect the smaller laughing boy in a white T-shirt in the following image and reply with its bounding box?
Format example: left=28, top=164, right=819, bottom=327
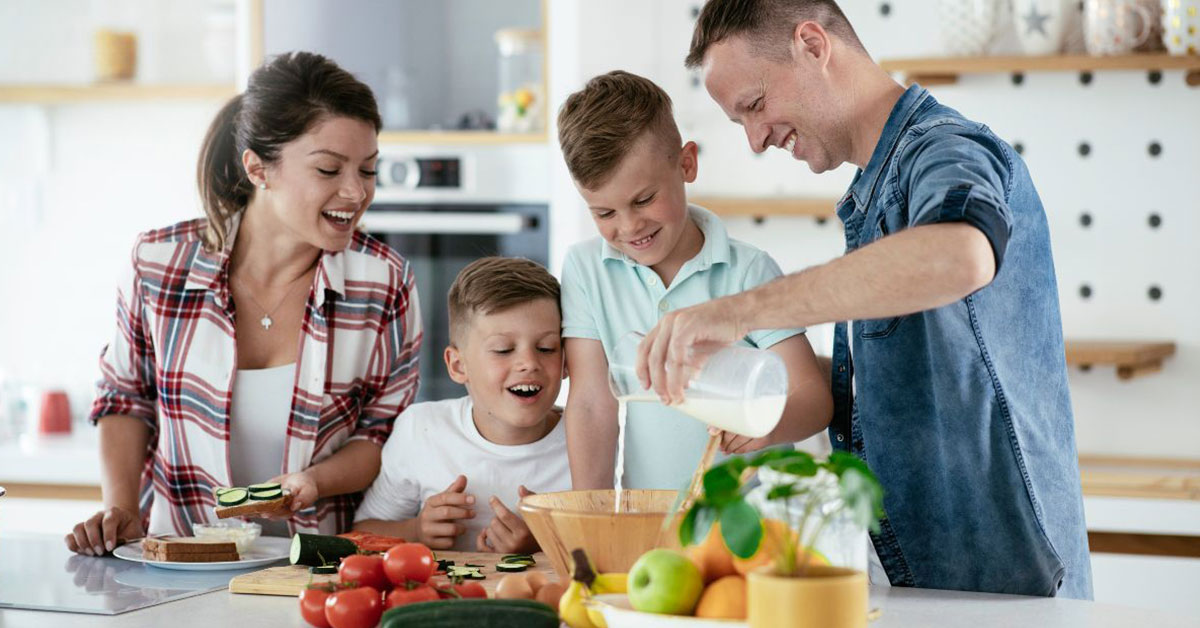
left=354, top=257, right=570, bottom=554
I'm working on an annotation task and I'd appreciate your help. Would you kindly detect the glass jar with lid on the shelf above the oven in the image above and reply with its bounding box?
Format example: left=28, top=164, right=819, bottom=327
left=496, top=29, right=546, bottom=133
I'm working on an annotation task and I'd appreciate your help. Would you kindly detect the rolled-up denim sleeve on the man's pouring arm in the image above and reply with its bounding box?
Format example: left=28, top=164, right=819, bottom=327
left=901, top=124, right=1013, bottom=273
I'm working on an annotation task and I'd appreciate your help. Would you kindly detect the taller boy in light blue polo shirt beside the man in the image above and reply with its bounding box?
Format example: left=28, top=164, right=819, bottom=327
left=558, top=71, right=833, bottom=489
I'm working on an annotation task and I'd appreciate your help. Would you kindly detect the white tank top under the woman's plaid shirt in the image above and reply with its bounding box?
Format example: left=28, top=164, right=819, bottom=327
left=229, top=363, right=296, bottom=537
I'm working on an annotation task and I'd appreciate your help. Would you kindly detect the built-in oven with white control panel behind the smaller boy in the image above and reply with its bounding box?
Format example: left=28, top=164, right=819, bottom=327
left=362, top=145, right=550, bottom=401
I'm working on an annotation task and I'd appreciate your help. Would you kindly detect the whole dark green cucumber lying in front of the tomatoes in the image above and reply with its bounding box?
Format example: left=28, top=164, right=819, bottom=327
left=380, top=598, right=559, bottom=628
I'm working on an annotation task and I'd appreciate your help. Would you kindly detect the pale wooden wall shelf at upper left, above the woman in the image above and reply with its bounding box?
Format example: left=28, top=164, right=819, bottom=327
left=0, top=83, right=238, bottom=104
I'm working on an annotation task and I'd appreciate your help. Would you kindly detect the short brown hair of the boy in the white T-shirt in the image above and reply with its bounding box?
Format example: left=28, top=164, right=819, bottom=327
left=446, top=257, right=563, bottom=345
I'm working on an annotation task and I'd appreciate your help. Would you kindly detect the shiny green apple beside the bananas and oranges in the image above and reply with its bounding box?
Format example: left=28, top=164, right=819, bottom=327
left=628, top=549, right=704, bottom=615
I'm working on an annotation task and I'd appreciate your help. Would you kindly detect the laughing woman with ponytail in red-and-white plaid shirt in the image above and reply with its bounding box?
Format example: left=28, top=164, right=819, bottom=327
left=66, top=53, right=421, bottom=555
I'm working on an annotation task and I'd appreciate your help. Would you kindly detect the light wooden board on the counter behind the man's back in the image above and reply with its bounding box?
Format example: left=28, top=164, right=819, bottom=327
left=1079, top=455, right=1200, bottom=501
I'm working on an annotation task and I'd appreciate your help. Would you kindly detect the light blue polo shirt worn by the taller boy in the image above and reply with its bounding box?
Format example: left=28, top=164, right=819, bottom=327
left=563, top=205, right=804, bottom=490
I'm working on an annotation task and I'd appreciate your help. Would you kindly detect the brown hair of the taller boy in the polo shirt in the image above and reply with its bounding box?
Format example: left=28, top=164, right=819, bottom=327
left=558, top=70, right=683, bottom=190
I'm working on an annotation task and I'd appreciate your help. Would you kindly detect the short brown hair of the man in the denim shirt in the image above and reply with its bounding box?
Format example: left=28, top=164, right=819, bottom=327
left=684, top=0, right=866, bottom=70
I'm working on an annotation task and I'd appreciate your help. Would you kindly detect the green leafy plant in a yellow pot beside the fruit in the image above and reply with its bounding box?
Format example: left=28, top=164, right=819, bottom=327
left=679, top=450, right=883, bottom=628
